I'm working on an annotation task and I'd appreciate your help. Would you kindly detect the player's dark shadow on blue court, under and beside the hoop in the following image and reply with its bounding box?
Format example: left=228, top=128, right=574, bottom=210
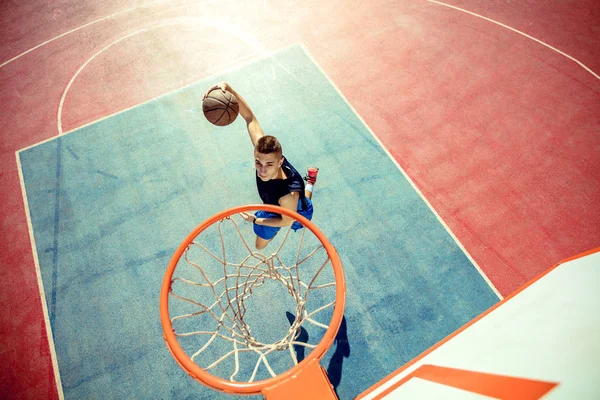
left=285, top=312, right=350, bottom=397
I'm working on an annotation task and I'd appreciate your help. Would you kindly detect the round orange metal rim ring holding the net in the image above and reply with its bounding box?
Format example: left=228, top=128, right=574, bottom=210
left=160, top=204, right=346, bottom=394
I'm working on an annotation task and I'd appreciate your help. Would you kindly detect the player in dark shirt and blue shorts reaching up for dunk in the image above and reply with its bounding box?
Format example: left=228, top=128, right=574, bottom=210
left=202, top=82, right=319, bottom=250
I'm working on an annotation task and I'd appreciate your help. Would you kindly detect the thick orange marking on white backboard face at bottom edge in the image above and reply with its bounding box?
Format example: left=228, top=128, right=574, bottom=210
left=378, top=364, right=558, bottom=400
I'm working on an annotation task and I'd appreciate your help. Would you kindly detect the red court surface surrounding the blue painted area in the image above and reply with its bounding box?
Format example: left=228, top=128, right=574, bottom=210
left=0, top=0, right=600, bottom=399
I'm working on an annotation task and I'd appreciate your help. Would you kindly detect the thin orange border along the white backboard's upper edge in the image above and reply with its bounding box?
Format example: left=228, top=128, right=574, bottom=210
left=356, top=247, right=600, bottom=400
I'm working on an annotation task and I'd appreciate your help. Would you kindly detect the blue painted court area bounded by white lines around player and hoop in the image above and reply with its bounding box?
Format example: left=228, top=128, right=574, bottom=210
left=20, top=47, right=497, bottom=398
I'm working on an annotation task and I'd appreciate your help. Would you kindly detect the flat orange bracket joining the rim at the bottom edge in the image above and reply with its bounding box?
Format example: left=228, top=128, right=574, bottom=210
left=261, top=359, right=338, bottom=400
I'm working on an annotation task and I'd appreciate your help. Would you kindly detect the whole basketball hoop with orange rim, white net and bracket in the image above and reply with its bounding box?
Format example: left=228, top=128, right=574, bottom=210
left=160, top=204, right=346, bottom=400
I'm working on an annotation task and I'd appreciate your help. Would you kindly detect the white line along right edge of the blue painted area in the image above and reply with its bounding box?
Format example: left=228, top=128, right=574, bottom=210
left=301, top=45, right=503, bottom=300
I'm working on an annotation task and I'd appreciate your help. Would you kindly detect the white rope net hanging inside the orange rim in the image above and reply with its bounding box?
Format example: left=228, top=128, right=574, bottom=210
left=169, top=211, right=336, bottom=382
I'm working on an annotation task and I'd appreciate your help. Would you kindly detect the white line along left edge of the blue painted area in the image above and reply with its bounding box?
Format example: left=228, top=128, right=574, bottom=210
left=15, top=152, right=65, bottom=399
